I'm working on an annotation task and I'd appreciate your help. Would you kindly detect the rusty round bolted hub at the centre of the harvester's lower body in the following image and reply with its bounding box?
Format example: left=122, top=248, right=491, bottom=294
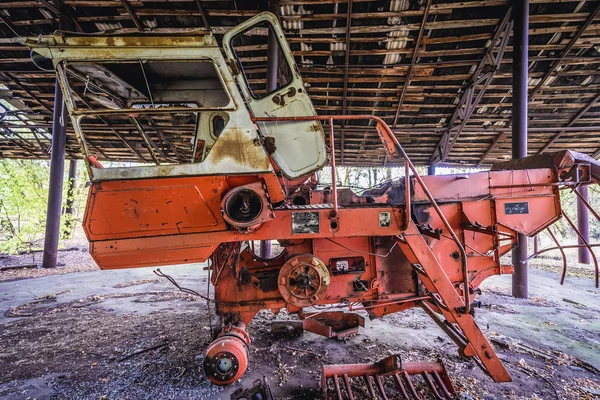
left=278, top=254, right=331, bottom=307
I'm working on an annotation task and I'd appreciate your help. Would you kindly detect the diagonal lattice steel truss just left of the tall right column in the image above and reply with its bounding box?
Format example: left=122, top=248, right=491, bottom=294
left=431, top=8, right=512, bottom=163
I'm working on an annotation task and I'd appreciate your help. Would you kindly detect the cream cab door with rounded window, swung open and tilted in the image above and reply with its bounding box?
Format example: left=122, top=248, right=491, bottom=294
left=223, top=12, right=327, bottom=179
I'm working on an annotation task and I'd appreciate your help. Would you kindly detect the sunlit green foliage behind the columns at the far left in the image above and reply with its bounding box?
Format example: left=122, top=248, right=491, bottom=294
left=0, top=159, right=87, bottom=254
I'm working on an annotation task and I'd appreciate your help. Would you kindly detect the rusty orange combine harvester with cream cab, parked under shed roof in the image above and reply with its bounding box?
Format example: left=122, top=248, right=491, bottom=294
left=26, top=13, right=600, bottom=398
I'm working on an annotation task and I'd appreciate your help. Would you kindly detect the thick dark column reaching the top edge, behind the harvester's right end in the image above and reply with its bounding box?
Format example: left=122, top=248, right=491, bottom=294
left=512, top=0, right=529, bottom=299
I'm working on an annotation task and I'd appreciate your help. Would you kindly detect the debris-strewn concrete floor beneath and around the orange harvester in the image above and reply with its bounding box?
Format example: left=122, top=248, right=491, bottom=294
left=0, top=265, right=600, bottom=399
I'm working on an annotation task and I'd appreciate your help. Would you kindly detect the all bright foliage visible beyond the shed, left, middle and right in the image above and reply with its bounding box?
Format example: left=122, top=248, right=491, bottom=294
left=0, top=160, right=600, bottom=253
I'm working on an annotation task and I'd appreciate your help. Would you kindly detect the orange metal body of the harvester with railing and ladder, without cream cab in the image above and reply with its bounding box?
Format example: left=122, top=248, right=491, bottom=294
left=79, top=115, right=600, bottom=383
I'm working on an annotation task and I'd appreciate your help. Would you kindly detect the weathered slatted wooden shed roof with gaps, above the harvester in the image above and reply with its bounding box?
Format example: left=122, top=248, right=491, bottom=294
left=0, top=0, right=600, bottom=166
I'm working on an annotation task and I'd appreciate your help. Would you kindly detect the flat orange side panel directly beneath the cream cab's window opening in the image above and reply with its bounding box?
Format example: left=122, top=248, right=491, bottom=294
left=84, top=175, right=284, bottom=241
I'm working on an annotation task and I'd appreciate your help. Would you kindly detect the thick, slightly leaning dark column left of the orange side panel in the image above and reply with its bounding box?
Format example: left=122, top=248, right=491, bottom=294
left=42, top=80, right=67, bottom=268
